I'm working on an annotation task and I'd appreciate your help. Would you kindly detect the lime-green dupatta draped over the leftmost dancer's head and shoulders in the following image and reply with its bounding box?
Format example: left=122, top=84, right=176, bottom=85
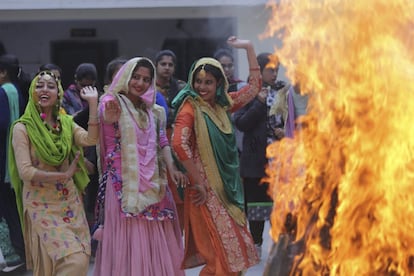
left=8, top=71, right=89, bottom=228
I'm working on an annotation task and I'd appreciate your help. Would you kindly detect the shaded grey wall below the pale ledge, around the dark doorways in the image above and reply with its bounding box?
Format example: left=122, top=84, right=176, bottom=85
left=0, top=19, right=234, bottom=75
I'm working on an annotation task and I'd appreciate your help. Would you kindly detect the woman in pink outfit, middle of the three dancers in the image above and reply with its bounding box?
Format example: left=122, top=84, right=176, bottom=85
left=94, top=58, right=186, bottom=276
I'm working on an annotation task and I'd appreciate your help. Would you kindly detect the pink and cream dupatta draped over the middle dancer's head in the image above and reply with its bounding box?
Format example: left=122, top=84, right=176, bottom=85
left=101, top=58, right=166, bottom=216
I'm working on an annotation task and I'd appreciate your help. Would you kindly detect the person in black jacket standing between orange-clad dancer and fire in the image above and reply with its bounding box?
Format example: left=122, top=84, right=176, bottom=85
left=233, top=53, right=288, bottom=256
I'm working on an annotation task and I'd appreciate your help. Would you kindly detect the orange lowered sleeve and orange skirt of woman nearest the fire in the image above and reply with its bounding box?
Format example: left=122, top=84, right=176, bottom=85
left=172, top=103, right=259, bottom=276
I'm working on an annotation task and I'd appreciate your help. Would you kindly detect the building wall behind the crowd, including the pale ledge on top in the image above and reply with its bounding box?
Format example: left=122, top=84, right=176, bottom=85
left=0, top=0, right=288, bottom=83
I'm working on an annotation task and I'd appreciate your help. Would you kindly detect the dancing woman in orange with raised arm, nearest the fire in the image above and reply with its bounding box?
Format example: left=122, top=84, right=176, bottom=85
left=172, top=37, right=261, bottom=276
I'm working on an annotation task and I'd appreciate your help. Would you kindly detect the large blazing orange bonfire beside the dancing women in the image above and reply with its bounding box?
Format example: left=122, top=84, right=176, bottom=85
left=263, top=0, right=414, bottom=275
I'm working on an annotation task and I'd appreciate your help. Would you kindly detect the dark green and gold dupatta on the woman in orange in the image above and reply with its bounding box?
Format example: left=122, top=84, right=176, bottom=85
left=172, top=58, right=246, bottom=225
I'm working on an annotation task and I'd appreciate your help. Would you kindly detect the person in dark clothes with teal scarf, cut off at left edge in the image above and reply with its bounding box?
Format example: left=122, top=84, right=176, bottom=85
left=0, top=54, right=25, bottom=271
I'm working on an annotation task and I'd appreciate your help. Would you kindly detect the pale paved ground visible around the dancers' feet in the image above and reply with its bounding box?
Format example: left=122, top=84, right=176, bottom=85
left=0, top=222, right=271, bottom=276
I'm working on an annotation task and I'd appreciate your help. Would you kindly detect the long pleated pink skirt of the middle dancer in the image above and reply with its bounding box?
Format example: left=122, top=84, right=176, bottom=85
left=94, top=179, right=184, bottom=276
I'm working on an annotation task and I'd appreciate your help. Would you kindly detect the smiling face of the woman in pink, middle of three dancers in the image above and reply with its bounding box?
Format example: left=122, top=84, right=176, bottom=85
left=127, top=66, right=152, bottom=101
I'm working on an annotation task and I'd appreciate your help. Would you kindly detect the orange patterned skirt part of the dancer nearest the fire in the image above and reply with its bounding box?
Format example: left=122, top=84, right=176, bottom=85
left=183, top=190, right=257, bottom=276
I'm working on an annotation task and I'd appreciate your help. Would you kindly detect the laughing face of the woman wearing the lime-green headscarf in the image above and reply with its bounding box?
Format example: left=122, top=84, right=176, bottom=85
left=35, top=74, right=59, bottom=110
